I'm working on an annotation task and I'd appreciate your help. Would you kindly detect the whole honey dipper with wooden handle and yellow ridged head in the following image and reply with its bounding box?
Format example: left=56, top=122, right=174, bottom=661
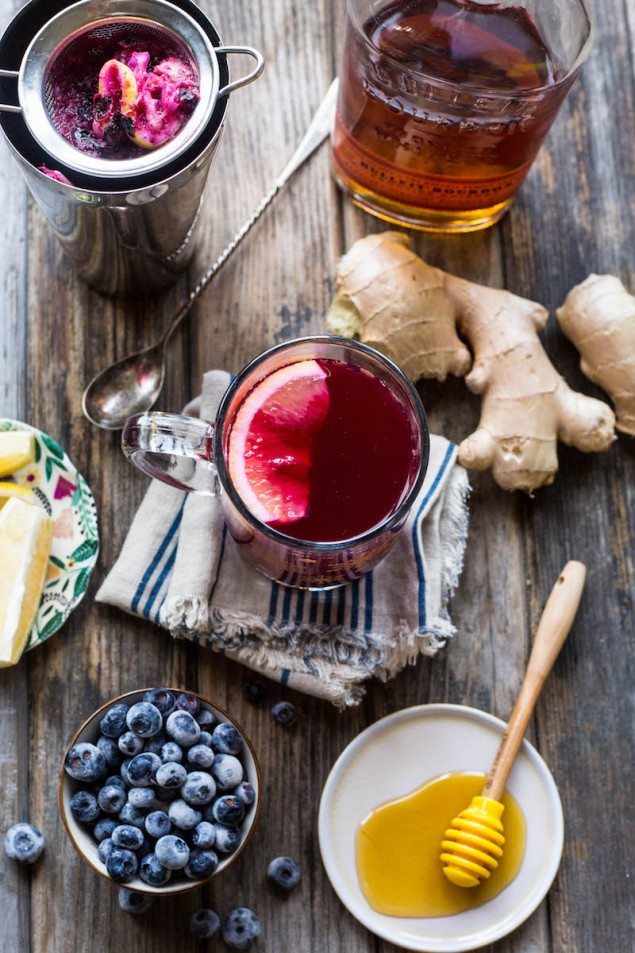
left=441, top=562, right=586, bottom=887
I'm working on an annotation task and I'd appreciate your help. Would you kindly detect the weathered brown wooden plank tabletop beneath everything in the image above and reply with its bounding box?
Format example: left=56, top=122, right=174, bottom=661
left=0, top=0, right=635, bottom=953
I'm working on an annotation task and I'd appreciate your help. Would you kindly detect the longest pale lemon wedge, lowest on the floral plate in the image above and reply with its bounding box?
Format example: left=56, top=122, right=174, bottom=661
left=0, top=497, right=53, bottom=668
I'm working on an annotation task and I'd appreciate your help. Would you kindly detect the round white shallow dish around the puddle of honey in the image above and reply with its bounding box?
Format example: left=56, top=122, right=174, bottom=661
left=319, top=705, right=564, bottom=953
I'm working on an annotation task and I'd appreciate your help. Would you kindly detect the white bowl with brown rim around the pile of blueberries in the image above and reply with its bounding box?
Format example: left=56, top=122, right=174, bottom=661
left=58, top=686, right=261, bottom=896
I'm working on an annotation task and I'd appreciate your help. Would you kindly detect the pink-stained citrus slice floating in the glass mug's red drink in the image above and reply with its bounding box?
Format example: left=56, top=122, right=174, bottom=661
left=227, top=361, right=329, bottom=524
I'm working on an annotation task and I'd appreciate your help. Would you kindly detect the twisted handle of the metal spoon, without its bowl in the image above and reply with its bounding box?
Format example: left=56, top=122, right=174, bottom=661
left=164, top=79, right=337, bottom=345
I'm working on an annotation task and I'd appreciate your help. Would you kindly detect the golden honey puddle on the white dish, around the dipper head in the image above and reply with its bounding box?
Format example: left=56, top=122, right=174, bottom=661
left=356, top=773, right=525, bottom=917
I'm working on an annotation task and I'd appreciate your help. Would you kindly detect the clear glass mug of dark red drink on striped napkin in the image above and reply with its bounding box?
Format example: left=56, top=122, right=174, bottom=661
left=122, top=335, right=429, bottom=590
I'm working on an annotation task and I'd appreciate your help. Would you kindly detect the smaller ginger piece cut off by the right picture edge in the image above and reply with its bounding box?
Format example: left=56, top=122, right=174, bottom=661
left=556, top=275, right=635, bottom=436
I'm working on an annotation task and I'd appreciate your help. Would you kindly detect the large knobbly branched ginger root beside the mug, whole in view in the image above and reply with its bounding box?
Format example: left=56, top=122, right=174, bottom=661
left=327, top=232, right=615, bottom=493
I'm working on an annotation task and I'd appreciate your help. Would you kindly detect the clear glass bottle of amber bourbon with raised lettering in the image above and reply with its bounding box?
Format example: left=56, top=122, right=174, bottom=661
left=331, top=0, right=593, bottom=232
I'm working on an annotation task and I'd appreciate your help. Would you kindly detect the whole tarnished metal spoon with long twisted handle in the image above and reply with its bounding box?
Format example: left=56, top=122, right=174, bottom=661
left=82, top=80, right=337, bottom=430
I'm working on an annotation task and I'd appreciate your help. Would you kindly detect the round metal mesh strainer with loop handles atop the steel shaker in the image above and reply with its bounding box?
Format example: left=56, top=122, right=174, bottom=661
left=0, top=0, right=264, bottom=178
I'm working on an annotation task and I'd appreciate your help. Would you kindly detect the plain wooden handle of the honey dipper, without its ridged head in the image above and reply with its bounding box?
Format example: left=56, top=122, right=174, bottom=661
left=483, top=562, right=586, bottom=801
